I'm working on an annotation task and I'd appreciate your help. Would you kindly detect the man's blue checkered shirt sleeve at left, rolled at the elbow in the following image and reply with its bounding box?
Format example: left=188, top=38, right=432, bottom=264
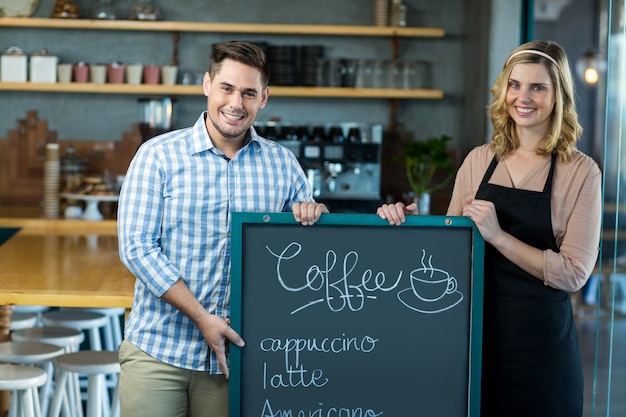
left=118, top=146, right=181, bottom=297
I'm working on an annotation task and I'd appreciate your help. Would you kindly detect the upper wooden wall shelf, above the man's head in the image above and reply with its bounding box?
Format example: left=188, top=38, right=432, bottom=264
left=0, top=17, right=445, bottom=38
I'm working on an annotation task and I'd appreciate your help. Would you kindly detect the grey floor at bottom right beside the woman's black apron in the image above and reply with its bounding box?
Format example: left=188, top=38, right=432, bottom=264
left=577, top=307, right=626, bottom=417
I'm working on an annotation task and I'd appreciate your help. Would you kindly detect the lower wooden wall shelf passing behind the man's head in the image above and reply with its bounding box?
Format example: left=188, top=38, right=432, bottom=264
left=0, top=82, right=443, bottom=99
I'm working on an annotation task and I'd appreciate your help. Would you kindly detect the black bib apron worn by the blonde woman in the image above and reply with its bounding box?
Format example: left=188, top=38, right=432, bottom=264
left=476, top=155, right=583, bottom=417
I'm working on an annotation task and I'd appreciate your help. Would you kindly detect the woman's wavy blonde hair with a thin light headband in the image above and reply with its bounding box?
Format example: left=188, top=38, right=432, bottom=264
left=488, top=41, right=583, bottom=162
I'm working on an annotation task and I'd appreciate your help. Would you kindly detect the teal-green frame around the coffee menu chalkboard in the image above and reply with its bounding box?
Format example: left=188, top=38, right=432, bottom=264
left=229, top=213, right=484, bottom=417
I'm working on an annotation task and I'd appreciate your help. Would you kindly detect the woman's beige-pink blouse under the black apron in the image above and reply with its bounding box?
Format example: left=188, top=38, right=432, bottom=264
left=448, top=144, right=602, bottom=292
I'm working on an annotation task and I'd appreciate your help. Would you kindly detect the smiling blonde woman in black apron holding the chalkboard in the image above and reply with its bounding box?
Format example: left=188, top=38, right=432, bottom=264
left=377, top=41, right=601, bottom=417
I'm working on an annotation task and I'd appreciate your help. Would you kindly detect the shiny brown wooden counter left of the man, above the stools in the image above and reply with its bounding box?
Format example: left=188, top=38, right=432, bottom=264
left=0, top=218, right=135, bottom=308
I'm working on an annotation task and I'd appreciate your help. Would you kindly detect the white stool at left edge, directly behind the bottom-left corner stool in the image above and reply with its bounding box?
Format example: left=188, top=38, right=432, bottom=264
left=0, top=341, right=65, bottom=416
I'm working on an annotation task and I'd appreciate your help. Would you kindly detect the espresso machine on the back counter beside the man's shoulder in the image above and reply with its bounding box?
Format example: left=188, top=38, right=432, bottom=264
left=256, top=122, right=383, bottom=213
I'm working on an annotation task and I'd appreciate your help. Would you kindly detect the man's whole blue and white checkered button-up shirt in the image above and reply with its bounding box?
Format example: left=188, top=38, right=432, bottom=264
left=118, top=112, right=313, bottom=373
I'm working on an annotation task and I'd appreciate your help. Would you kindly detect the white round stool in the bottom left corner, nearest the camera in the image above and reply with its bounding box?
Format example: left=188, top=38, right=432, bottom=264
left=0, top=364, right=48, bottom=417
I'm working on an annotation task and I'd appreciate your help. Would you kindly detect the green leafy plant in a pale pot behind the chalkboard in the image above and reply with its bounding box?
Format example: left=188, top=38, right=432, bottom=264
left=400, top=135, right=454, bottom=214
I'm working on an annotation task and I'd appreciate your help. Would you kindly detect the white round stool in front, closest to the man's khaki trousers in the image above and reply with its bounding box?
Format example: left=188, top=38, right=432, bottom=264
left=49, top=350, right=120, bottom=417
